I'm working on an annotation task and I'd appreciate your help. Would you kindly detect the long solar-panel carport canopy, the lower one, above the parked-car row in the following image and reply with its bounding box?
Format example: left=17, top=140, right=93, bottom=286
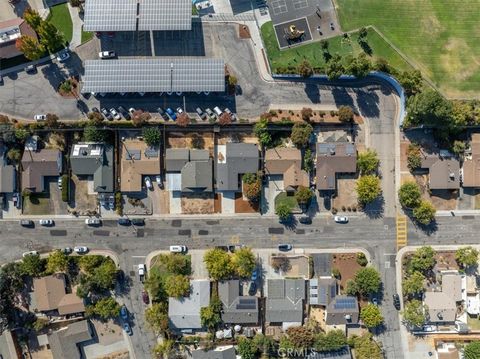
left=82, top=58, right=225, bottom=93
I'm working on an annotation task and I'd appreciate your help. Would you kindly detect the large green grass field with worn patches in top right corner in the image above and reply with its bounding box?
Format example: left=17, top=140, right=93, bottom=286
left=336, top=0, right=480, bottom=98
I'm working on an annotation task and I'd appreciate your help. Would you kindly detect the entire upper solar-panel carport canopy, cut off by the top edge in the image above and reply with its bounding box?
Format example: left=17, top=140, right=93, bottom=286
left=84, top=0, right=192, bottom=32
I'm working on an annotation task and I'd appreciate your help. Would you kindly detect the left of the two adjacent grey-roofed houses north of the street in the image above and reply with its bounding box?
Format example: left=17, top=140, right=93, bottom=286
left=165, top=148, right=213, bottom=193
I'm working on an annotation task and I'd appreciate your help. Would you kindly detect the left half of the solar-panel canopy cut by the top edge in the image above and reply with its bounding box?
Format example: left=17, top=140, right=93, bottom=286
left=83, top=0, right=137, bottom=31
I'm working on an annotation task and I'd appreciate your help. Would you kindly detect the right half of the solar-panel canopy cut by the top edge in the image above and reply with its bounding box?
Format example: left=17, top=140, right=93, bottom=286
left=138, top=0, right=192, bottom=31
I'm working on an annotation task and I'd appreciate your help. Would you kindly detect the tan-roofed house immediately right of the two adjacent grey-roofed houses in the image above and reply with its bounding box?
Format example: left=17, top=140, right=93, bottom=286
left=265, top=147, right=310, bottom=192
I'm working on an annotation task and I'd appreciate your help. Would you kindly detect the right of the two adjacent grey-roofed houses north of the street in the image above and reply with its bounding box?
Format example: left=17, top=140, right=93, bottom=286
left=216, top=142, right=260, bottom=192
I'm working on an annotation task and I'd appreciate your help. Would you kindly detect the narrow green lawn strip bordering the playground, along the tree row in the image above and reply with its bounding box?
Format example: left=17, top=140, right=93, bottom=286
left=261, top=22, right=411, bottom=72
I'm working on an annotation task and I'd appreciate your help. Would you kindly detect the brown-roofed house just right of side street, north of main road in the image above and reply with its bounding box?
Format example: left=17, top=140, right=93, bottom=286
left=420, top=151, right=460, bottom=190
